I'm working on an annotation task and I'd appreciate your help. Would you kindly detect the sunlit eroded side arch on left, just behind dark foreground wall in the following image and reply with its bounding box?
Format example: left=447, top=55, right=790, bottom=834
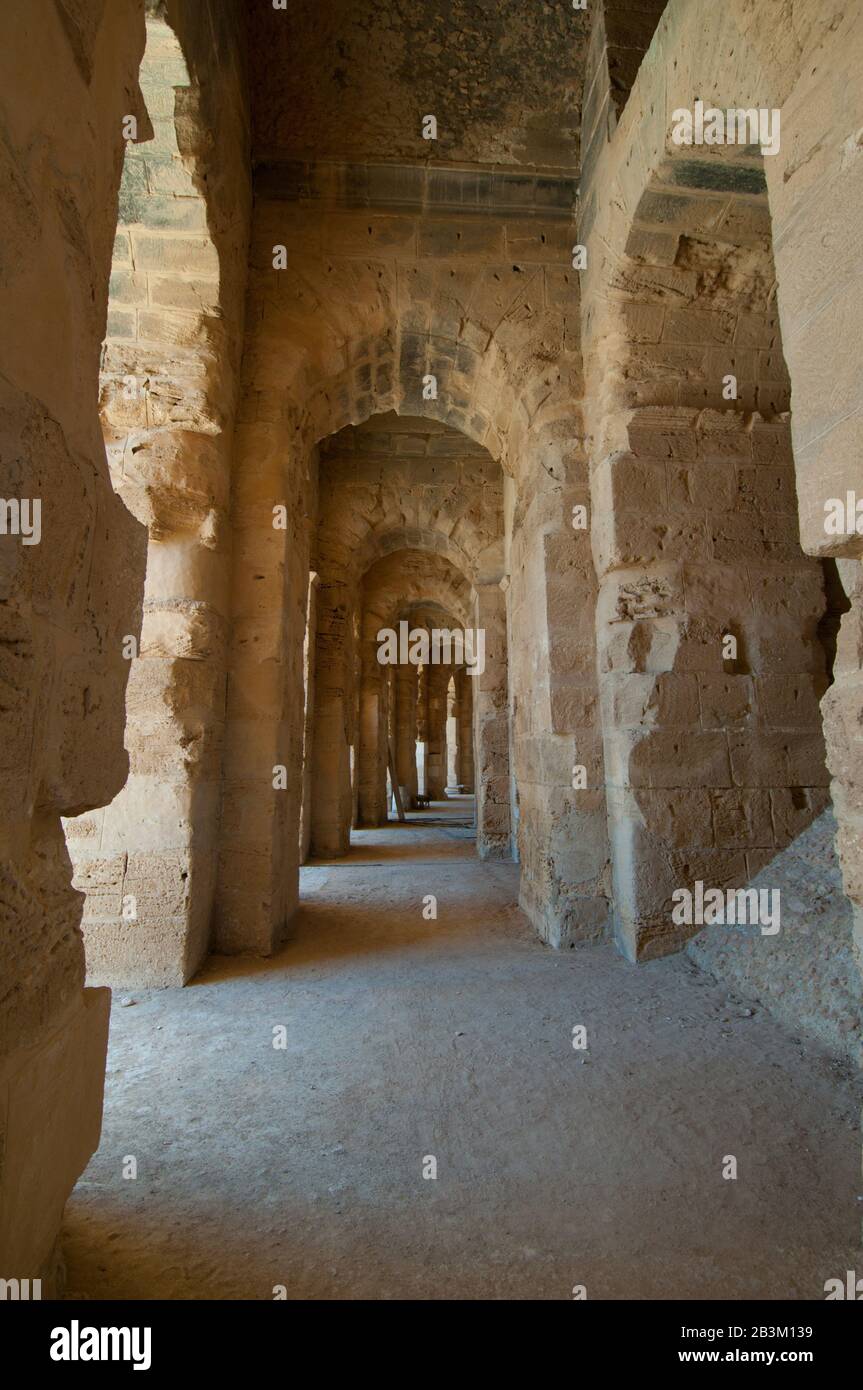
left=59, top=0, right=249, bottom=984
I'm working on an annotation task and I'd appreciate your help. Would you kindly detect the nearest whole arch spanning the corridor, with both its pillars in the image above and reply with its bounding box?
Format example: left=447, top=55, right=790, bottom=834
left=217, top=165, right=607, bottom=949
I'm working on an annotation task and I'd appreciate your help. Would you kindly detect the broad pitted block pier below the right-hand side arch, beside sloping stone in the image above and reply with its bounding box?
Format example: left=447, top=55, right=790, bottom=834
left=593, top=407, right=828, bottom=960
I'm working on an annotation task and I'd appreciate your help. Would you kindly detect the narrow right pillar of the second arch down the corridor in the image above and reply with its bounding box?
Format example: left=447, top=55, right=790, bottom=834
left=467, top=584, right=511, bottom=859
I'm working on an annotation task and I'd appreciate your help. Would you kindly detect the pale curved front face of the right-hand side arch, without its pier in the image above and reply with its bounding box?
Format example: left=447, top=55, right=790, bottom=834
left=580, top=0, right=863, bottom=553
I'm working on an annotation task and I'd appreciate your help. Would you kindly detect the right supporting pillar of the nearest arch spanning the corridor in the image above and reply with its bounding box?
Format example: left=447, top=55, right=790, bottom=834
left=502, top=422, right=610, bottom=947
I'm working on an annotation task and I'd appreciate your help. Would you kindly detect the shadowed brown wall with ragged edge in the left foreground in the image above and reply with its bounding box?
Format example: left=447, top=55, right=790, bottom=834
left=0, top=0, right=146, bottom=1294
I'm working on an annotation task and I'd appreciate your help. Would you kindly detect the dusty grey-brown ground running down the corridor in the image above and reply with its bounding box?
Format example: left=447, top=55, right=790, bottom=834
left=65, top=812, right=860, bottom=1298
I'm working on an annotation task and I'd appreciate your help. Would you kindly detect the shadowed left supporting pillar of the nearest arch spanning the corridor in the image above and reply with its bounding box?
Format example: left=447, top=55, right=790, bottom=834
left=214, top=419, right=311, bottom=955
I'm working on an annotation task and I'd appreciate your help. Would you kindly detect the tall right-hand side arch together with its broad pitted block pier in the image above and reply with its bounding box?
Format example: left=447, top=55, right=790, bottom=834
left=580, top=0, right=850, bottom=956
